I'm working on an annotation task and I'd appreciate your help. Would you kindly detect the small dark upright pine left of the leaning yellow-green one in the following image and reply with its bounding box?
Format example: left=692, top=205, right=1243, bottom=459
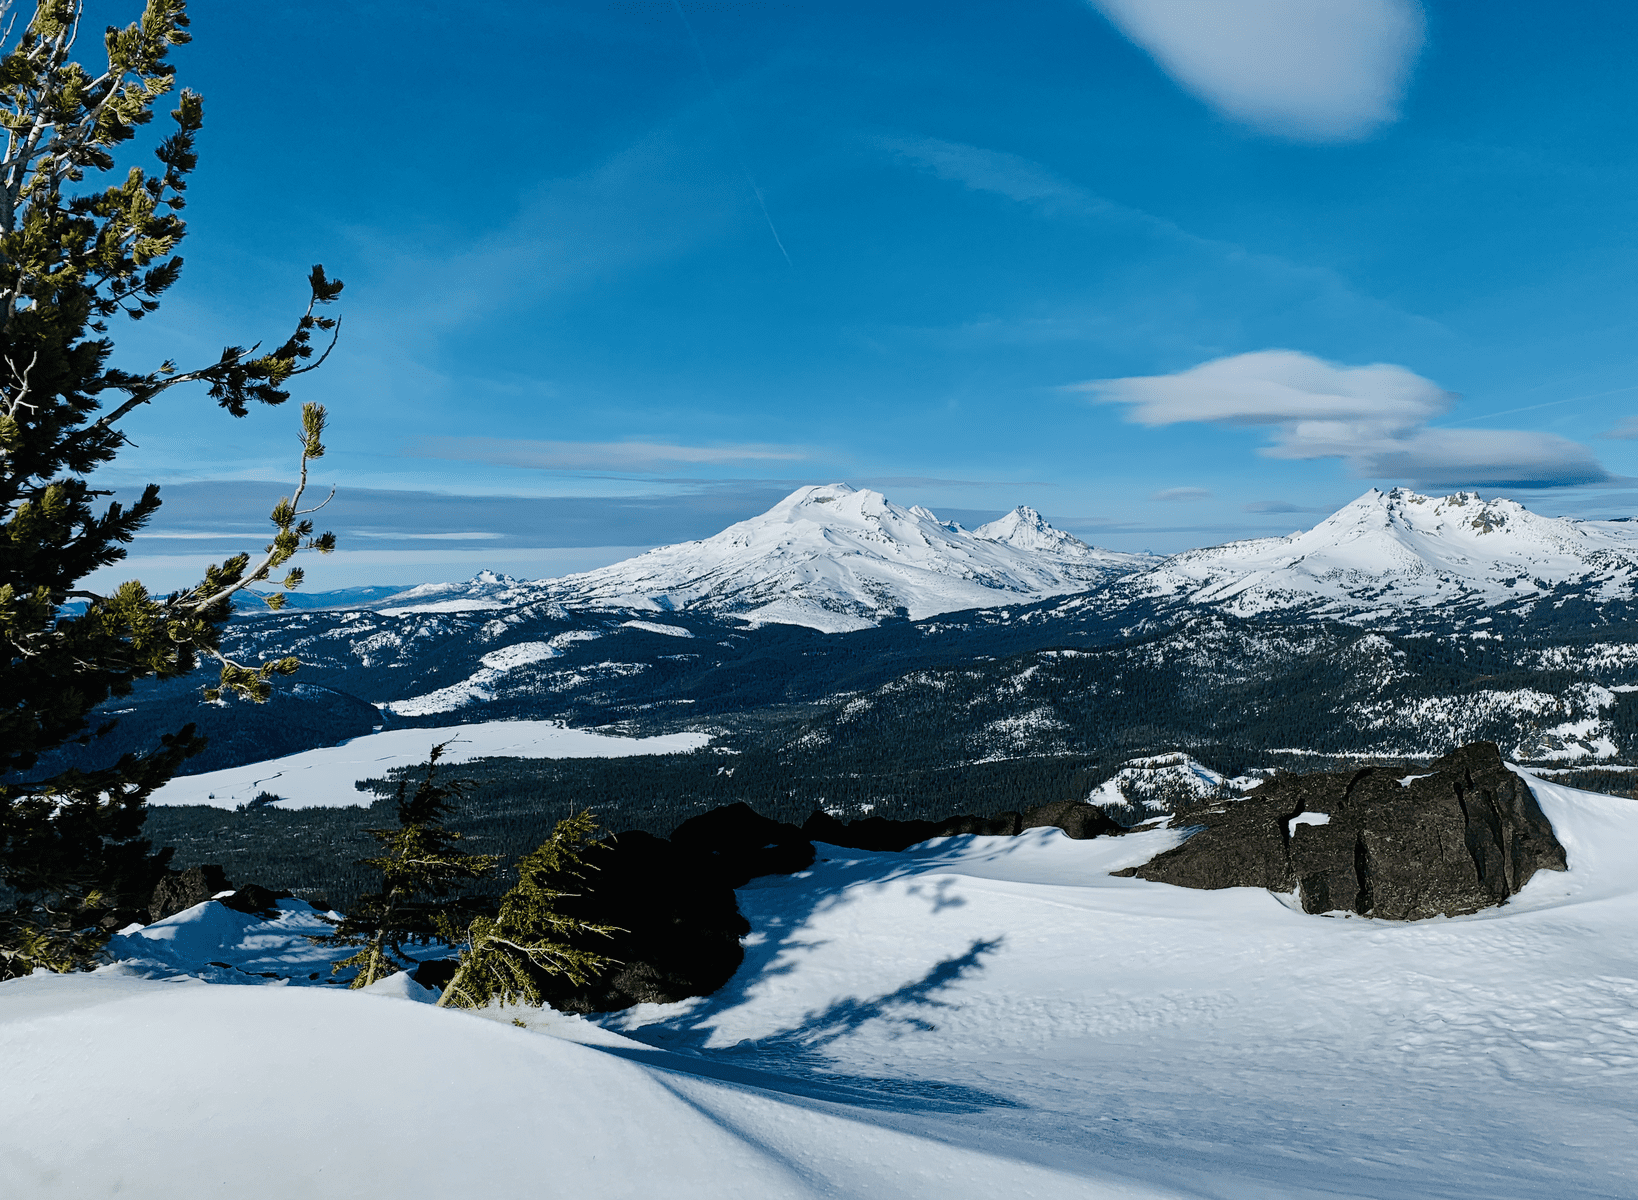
left=318, top=742, right=500, bottom=987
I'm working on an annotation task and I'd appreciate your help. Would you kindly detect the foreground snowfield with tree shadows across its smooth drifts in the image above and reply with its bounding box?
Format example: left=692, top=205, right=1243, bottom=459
left=0, top=776, right=1638, bottom=1200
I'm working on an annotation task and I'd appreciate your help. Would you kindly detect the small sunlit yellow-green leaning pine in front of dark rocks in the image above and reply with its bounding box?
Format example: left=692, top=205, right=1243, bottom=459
left=437, top=810, right=621, bottom=1008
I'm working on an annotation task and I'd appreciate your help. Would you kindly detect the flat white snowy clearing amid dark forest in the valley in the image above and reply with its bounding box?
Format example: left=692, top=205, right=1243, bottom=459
left=147, top=720, right=711, bottom=809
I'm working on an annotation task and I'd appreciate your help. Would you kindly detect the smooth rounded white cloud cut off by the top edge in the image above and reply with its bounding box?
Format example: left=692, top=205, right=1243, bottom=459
left=1091, top=0, right=1425, bottom=141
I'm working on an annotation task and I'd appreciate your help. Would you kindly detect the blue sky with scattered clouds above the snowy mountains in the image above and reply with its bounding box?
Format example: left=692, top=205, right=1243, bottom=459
left=93, top=0, right=1638, bottom=588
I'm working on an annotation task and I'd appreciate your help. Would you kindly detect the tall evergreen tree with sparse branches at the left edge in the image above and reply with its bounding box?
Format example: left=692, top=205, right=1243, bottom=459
left=0, top=0, right=341, bottom=977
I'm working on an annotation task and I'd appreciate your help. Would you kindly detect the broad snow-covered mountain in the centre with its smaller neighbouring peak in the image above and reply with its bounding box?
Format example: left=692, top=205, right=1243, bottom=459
left=383, top=483, right=1155, bottom=632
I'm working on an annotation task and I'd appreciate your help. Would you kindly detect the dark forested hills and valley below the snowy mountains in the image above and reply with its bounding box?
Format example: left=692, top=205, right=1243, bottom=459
left=41, top=576, right=1638, bottom=902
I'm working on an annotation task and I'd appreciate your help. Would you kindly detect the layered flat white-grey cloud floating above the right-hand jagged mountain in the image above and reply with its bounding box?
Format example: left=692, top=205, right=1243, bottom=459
left=1079, top=350, right=1610, bottom=488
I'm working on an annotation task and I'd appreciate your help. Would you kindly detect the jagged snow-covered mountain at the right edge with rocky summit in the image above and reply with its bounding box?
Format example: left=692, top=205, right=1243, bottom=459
left=1117, top=488, right=1638, bottom=616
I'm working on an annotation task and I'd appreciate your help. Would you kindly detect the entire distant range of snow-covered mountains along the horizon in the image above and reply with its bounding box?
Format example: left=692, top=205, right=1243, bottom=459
left=369, top=483, right=1638, bottom=634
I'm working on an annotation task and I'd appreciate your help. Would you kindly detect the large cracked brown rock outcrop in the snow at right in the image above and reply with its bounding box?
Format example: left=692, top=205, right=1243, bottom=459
left=1117, top=742, right=1566, bottom=920
